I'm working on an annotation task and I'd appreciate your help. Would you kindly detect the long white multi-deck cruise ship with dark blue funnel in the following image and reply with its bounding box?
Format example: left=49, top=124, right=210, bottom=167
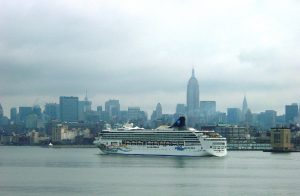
left=94, top=117, right=227, bottom=157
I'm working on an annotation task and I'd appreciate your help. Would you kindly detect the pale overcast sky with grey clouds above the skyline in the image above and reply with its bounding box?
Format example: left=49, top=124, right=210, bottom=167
left=0, top=0, right=300, bottom=115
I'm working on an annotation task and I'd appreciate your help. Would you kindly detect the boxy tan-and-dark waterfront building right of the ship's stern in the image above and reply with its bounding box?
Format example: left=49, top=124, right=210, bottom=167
left=271, top=128, right=293, bottom=151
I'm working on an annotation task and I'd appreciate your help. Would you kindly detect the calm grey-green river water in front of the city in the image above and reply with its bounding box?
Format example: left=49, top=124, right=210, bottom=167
left=0, top=146, right=300, bottom=196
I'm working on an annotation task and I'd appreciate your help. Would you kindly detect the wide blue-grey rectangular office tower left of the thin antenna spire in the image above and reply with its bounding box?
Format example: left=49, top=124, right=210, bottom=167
left=59, top=96, right=78, bottom=122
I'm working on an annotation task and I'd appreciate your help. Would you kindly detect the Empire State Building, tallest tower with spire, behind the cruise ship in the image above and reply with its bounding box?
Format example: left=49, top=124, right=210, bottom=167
left=186, top=69, right=199, bottom=116
